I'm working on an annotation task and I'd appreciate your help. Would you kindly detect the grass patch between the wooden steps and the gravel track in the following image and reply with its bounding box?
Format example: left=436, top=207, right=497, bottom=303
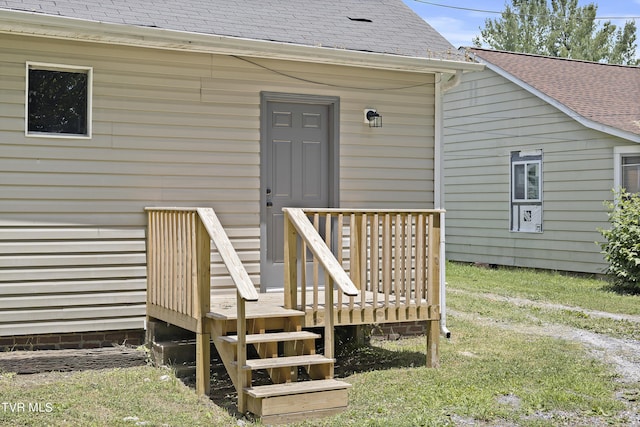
left=318, top=319, right=622, bottom=426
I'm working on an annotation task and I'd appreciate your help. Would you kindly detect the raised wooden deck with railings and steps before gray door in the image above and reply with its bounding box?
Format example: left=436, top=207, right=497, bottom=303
left=147, top=208, right=443, bottom=423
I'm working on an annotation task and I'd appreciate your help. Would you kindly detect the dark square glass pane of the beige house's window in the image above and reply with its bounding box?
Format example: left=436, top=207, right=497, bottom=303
left=28, top=70, right=88, bottom=135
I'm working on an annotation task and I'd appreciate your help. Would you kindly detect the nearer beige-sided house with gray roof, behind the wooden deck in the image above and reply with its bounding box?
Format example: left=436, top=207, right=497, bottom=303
left=0, top=0, right=482, bottom=342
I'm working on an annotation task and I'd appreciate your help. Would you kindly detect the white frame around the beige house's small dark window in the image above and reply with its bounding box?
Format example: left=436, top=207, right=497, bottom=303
left=24, top=61, right=93, bottom=139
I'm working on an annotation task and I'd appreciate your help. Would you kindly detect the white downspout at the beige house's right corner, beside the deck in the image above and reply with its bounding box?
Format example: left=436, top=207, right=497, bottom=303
left=433, top=70, right=462, bottom=338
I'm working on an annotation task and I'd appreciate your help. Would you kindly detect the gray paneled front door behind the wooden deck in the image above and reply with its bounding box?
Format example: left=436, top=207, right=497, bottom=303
left=261, top=102, right=330, bottom=291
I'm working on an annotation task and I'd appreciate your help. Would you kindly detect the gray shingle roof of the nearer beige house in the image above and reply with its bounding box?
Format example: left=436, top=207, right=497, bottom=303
left=0, top=0, right=457, bottom=59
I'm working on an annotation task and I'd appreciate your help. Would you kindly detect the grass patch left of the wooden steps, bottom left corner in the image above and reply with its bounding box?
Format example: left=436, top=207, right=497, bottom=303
left=0, top=366, right=236, bottom=426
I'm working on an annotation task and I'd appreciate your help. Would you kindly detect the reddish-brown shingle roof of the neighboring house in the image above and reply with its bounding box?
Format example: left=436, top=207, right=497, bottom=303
left=468, top=48, right=640, bottom=135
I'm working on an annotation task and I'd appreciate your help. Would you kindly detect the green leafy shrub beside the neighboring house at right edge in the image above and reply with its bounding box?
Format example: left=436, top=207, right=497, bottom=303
left=599, top=189, right=640, bottom=290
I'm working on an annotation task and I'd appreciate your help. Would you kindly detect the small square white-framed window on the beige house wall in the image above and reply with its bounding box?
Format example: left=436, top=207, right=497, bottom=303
left=25, top=62, right=93, bottom=138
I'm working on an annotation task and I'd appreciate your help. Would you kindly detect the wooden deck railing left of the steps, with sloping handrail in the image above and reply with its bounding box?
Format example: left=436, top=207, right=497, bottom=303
left=146, top=208, right=258, bottom=403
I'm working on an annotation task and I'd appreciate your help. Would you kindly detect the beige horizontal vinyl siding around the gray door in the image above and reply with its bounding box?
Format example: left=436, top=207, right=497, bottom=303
left=0, top=34, right=434, bottom=335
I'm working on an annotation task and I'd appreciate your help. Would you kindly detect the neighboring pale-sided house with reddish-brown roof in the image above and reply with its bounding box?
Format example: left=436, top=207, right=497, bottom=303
left=444, top=48, right=640, bottom=273
